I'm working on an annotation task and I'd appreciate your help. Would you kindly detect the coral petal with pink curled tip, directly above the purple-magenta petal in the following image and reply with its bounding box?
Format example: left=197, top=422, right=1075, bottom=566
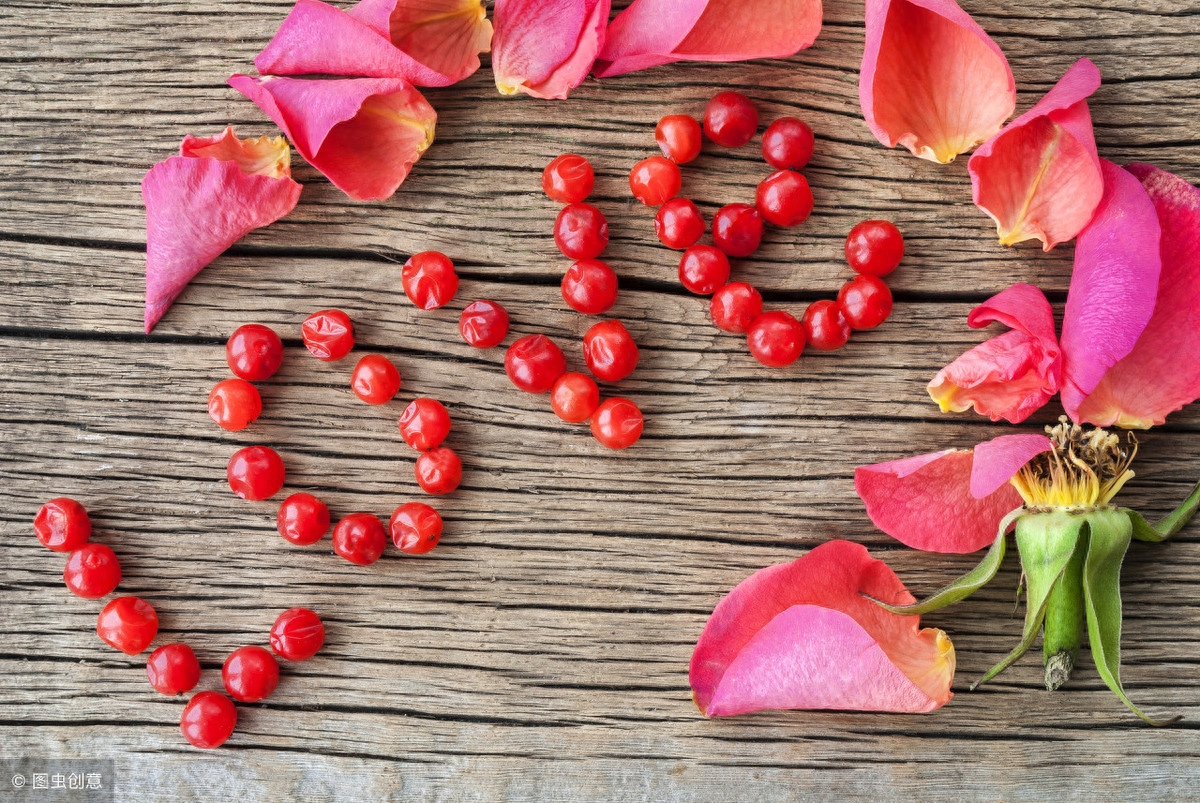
left=968, top=59, right=1104, bottom=251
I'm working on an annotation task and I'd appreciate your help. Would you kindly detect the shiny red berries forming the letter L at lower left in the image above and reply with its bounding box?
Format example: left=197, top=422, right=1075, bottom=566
left=34, top=497, right=325, bottom=748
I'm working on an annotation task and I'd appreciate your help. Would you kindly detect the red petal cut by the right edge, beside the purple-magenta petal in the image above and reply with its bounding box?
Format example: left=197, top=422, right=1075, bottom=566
left=1078, top=164, right=1200, bottom=429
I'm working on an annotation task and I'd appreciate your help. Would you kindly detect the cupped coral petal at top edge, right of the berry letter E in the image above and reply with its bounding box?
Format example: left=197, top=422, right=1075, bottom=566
left=858, top=0, right=1016, bottom=163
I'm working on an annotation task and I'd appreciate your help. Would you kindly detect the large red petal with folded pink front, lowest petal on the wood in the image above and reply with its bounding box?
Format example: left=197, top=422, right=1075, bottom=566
left=689, top=540, right=954, bottom=717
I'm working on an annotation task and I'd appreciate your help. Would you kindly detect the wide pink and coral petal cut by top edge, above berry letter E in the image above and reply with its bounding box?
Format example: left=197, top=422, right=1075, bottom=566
left=595, top=0, right=821, bottom=78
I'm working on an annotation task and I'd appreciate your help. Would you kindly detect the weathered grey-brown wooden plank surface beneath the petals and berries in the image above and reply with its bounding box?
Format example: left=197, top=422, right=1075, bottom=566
left=0, top=0, right=1200, bottom=801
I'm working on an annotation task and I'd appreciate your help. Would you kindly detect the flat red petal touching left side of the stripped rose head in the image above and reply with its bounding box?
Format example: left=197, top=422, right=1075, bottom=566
left=854, top=450, right=1021, bottom=553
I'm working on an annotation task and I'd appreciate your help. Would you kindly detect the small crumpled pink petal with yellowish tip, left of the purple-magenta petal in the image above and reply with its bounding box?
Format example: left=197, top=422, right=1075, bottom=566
left=928, top=283, right=1062, bottom=424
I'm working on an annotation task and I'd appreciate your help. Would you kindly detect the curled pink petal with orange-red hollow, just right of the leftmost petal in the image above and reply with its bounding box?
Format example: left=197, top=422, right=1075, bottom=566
left=229, top=76, right=437, bottom=200
